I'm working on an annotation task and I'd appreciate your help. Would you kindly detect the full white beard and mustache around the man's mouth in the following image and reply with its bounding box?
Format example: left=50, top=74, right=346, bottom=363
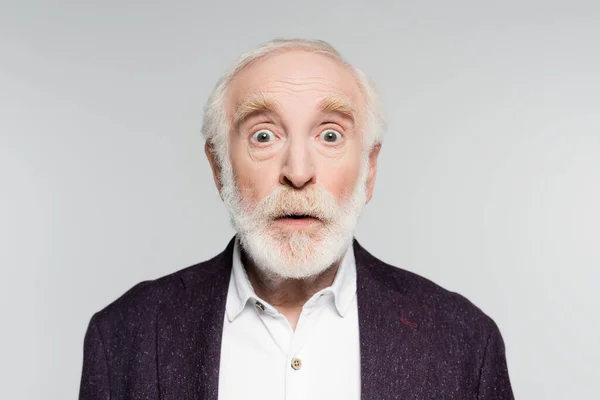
left=221, top=157, right=368, bottom=280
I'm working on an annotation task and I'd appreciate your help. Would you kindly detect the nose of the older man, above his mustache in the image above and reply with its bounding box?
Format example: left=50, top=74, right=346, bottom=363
left=279, top=139, right=316, bottom=189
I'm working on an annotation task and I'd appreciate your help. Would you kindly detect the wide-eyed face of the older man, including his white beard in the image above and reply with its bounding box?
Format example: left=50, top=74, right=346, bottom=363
left=212, top=51, right=377, bottom=278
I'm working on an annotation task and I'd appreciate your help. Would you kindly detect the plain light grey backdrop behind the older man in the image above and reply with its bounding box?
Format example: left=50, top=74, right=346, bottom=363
left=0, top=1, right=600, bottom=399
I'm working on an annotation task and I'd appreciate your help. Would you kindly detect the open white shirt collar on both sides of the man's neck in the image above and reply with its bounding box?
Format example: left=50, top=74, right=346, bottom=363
left=226, top=238, right=356, bottom=322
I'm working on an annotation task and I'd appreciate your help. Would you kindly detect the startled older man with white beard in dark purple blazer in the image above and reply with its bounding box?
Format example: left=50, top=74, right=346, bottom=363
left=80, top=40, right=513, bottom=400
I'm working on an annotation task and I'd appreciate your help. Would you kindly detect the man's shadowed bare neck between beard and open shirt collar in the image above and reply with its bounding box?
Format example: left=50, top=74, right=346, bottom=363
left=242, top=251, right=340, bottom=329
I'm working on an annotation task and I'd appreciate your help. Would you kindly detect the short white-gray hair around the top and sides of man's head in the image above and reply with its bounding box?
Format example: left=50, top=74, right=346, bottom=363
left=202, top=39, right=385, bottom=168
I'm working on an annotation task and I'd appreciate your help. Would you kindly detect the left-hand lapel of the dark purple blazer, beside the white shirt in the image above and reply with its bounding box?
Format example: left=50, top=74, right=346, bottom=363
left=157, top=239, right=233, bottom=400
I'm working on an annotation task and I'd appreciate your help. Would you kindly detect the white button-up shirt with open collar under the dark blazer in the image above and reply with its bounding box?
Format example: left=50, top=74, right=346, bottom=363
left=219, top=240, right=360, bottom=400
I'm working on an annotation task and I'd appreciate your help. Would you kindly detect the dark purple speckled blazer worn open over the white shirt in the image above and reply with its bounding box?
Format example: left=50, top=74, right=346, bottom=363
left=79, top=240, right=513, bottom=400
